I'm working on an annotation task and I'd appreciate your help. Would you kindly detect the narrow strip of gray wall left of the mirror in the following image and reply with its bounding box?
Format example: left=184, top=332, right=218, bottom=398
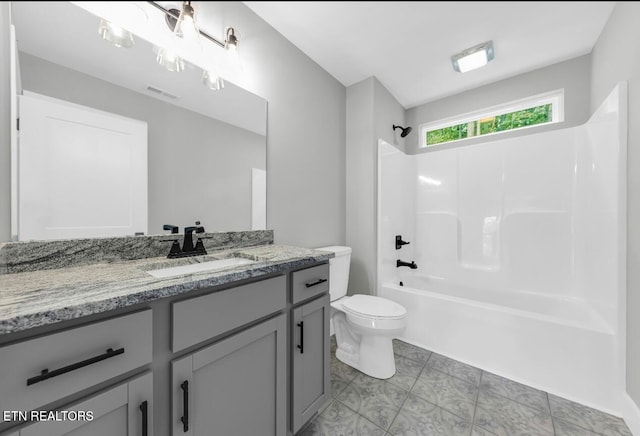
left=0, top=2, right=11, bottom=241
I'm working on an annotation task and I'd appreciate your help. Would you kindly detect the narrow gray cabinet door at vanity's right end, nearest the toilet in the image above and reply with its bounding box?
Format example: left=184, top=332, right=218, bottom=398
left=291, top=295, right=330, bottom=433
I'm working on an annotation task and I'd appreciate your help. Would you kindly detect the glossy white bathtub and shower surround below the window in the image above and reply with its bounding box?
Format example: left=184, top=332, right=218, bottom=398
left=377, top=83, right=627, bottom=415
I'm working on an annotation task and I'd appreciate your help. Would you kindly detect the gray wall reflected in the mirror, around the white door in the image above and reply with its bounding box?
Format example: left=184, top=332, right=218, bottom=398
left=19, top=53, right=266, bottom=234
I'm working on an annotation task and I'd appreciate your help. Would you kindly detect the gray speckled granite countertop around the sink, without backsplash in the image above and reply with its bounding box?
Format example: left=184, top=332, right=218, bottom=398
left=0, top=244, right=333, bottom=334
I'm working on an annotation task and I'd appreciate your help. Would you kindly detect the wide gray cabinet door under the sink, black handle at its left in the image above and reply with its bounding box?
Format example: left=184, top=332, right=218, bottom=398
left=171, top=314, right=287, bottom=436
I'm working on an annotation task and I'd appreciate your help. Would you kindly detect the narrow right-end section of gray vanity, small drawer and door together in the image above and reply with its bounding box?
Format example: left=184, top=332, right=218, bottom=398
left=290, top=264, right=331, bottom=434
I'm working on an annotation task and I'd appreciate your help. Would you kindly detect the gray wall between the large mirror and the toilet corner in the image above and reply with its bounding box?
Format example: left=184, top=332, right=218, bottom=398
left=215, top=2, right=346, bottom=247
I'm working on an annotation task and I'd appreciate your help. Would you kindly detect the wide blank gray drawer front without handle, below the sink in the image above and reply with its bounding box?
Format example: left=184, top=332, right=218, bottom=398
left=171, top=276, right=287, bottom=353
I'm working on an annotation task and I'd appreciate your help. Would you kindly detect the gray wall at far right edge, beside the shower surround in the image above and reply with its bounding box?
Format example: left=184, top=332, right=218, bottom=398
left=591, top=2, right=640, bottom=406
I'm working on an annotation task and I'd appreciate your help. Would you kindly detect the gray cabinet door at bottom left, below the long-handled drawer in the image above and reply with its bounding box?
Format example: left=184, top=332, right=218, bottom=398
left=16, top=373, right=153, bottom=436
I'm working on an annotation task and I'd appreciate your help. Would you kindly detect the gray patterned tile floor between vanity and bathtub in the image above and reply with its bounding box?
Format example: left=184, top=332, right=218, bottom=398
left=298, top=337, right=632, bottom=436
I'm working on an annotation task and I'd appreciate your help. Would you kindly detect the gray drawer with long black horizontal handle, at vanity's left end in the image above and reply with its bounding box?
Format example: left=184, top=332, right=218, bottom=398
left=0, top=310, right=153, bottom=410
